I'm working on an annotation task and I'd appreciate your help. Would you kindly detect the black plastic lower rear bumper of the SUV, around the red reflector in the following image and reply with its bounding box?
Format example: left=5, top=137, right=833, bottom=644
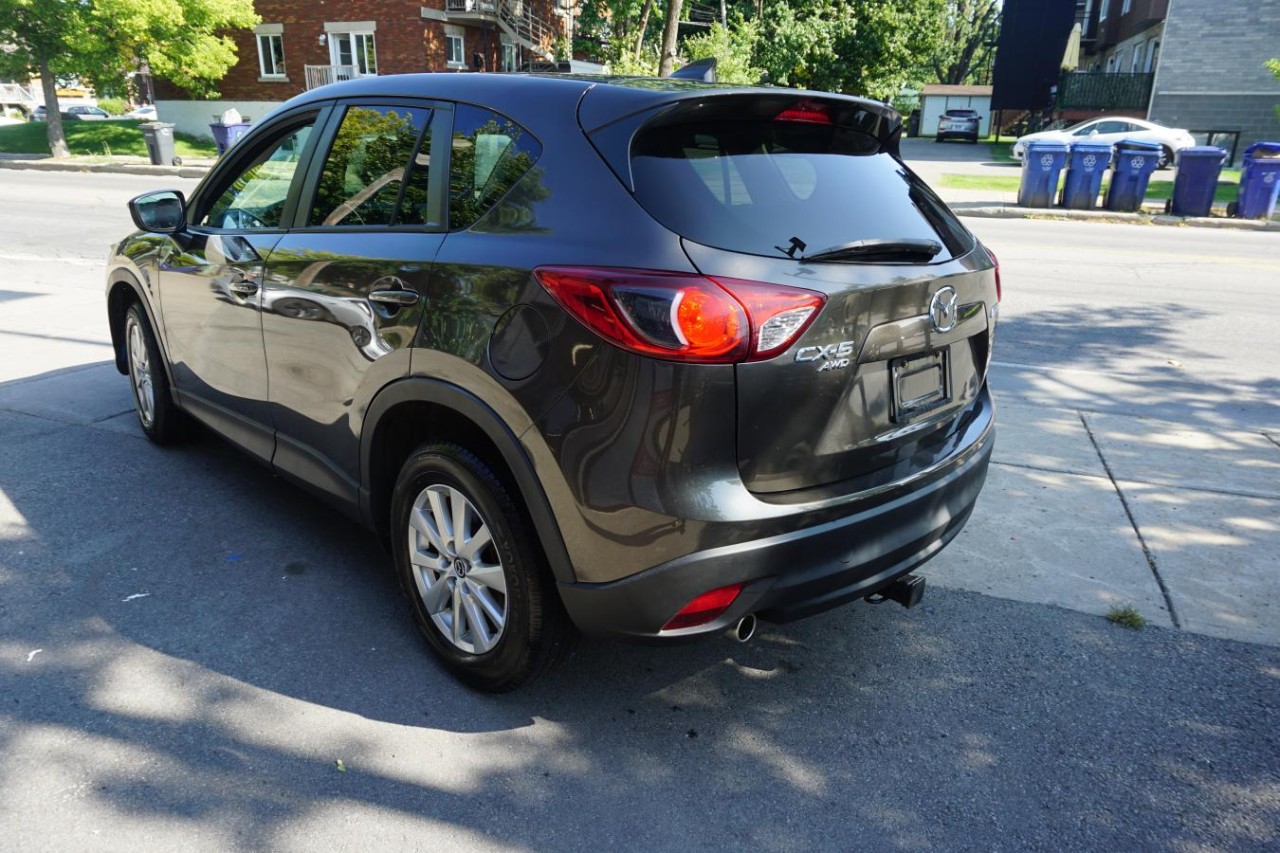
left=559, top=403, right=995, bottom=642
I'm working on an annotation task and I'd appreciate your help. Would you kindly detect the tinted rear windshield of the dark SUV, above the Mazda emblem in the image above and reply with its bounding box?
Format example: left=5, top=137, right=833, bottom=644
left=631, top=119, right=972, bottom=260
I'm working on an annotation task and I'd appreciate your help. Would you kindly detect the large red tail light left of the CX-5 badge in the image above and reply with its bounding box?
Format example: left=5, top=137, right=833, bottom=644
left=534, top=266, right=827, bottom=364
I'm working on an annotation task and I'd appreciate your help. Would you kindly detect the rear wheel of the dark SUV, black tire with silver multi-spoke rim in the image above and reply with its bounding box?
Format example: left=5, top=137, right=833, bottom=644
left=392, top=443, right=577, bottom=693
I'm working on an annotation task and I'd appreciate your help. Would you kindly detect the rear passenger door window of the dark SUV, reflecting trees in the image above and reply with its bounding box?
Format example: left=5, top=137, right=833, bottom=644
left=307, top=106, right=431, bottom=227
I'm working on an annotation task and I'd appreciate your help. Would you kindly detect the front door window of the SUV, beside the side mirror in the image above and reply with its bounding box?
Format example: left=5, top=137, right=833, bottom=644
left=198, top=124, right=311, bottom=231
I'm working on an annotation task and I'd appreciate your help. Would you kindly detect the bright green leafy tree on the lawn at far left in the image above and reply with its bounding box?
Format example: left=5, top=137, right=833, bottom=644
left=0, top=0, right=260, bottom=158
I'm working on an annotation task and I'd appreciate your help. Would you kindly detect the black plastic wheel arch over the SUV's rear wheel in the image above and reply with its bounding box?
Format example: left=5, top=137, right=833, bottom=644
left=360, top=377, right=576, bottom=583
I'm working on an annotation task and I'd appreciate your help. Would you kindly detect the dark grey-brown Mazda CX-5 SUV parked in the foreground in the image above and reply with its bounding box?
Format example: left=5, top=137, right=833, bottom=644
left=108, top=74, right=1000, bottom=690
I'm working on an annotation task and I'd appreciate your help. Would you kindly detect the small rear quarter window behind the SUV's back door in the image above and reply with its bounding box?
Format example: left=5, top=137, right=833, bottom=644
left=449, top=105, right=543, bottom=229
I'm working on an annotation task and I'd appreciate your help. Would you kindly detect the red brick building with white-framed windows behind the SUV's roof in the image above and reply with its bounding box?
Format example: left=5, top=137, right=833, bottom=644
left=156, top=0, right=570, bottom=136
